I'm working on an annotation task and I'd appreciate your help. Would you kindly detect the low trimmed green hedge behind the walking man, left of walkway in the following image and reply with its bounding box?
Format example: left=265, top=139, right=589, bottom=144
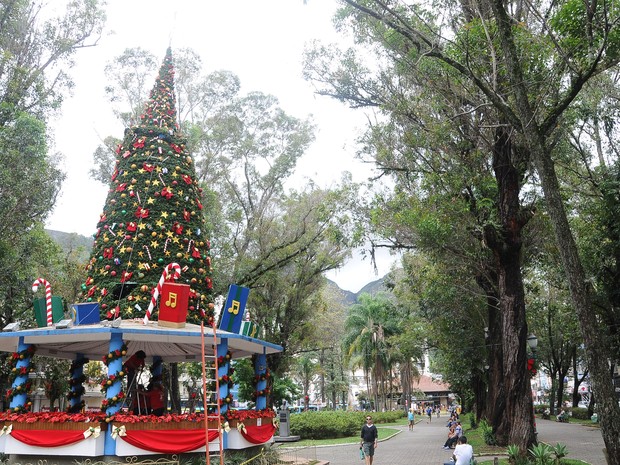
left=290, top=410, right=406, bottom=439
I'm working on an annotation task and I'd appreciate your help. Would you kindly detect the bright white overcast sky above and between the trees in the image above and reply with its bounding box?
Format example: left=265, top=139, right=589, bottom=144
left=47, top=0, right=394, bottom=292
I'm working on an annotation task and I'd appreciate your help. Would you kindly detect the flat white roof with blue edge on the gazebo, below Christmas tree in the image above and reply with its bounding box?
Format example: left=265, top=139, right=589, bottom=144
left=0, top=320, right=282, bottom=362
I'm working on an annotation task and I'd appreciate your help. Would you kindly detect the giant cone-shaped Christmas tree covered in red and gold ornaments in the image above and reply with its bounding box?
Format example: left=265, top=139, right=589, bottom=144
left=82, top=49, right=213, bottom=324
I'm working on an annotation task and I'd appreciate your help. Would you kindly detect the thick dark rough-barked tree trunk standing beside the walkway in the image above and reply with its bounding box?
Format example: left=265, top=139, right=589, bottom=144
left=485, top=126, right=536, bottom=451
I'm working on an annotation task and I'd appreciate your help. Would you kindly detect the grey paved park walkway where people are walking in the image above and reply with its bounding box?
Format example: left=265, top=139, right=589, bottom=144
left=306, top=417, right=606, bottom=465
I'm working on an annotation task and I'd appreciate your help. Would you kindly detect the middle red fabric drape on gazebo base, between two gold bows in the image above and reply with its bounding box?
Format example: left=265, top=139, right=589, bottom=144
left=119, top=429, right=218, bottom=454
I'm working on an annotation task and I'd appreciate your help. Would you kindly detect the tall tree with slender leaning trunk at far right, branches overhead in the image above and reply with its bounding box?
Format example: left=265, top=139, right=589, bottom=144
left=308, top=0, right=620, bottom=454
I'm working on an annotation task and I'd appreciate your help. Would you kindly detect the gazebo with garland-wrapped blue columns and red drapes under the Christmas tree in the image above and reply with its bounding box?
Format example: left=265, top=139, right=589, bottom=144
left=0, top=320, right=281, bottom=457
